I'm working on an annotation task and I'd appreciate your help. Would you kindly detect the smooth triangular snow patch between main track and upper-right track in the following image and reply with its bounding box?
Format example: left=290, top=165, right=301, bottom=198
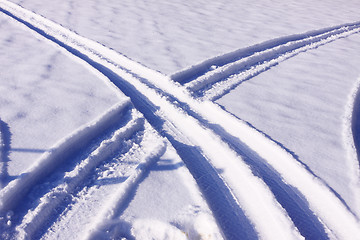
left=218, top=35, right=360, bottom=214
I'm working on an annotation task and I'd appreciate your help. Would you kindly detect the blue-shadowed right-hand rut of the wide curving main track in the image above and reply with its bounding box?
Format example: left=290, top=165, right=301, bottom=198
left=133, top=82, right=332, bottom=239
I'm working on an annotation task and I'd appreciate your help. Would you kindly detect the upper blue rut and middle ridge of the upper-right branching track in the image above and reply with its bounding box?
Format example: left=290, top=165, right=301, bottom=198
left=171, top=22, right=360, bottom=98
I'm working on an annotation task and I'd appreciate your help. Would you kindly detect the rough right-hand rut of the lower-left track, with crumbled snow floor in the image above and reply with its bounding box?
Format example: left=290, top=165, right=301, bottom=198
left=39, top=122, right=166, bottom=239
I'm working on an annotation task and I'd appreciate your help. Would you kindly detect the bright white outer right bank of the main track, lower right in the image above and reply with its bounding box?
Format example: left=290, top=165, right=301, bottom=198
left=195, top=103, right=360, bottom=239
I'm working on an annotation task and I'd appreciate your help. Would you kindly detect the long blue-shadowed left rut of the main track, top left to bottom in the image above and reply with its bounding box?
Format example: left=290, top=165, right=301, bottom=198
left=0, top=8, right=258, bottom=239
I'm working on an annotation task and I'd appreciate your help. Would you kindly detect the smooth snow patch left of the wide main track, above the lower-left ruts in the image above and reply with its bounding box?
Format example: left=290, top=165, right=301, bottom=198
left=0, top=14, right=124, bottom=178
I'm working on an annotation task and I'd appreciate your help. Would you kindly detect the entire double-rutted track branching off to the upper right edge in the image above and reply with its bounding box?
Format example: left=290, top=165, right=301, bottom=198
left=171, top=22, right=360, bottom=100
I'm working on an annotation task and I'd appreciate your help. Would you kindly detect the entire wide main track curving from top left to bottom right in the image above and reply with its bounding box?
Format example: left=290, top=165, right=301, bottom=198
left=0, top=1, right=360, bottom=239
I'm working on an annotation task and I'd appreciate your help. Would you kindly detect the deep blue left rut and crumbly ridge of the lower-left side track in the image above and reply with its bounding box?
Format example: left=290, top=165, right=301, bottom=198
left=0, top=99, right=145, bottom=239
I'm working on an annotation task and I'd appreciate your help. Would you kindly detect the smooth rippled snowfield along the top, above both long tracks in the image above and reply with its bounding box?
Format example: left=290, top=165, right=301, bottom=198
left=4, top=0, right=359, bottom=74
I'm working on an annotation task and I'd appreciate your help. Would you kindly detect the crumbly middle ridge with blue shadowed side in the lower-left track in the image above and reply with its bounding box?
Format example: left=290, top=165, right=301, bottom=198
left=17, top=109, right=144, bottom=239
